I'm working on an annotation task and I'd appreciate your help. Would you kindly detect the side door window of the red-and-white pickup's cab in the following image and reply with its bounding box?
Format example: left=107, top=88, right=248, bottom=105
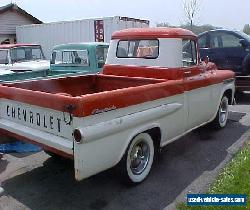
left=182, top=39, right=197, bottom=67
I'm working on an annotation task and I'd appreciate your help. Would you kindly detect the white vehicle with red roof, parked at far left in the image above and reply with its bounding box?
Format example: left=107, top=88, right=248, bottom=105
left=0, top=44, right=49, bottom=73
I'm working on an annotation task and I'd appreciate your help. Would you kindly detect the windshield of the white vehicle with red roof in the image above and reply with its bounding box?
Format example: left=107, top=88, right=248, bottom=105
left=10, top=46, right=45, bottom=62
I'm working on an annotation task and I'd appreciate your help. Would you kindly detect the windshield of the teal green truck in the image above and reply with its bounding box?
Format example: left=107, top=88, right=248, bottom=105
left=51, top=50, right=89, bottom=66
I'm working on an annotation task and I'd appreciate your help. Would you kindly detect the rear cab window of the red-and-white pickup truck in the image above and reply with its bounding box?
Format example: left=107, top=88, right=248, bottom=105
left=116, top=39, right=159, bottom=59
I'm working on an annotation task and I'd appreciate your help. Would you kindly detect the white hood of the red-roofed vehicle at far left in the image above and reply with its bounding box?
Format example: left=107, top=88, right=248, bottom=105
left=9, top=60, right=50, bottom=71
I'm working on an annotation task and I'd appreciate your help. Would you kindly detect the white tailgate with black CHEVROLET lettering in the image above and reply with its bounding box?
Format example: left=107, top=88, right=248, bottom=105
left=0, top=99, right=73, bottom=154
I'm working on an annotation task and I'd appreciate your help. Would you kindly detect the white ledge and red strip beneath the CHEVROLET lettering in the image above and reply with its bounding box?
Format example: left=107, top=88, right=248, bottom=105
left=0, top=119, right=73, bottom=158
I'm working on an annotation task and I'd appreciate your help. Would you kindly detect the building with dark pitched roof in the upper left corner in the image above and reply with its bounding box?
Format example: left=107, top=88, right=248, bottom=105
left=0, top=3, right=42, bottom=44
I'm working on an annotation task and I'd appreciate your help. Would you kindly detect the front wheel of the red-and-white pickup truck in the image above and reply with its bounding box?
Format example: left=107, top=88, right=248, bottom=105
left=212, top=96, right=229, bottom=129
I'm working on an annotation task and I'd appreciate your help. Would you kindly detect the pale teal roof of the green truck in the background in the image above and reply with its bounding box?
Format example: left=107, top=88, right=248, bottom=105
left=53, top=42, right=109, bottom=50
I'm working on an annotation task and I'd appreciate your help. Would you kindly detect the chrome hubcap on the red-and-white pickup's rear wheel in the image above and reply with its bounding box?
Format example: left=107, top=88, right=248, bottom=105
left=130, top=141, right=150, bottom=175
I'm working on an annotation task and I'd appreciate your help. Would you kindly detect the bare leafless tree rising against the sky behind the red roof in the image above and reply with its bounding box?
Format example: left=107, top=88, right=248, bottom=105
left=183, top=0, right=200, bottom=30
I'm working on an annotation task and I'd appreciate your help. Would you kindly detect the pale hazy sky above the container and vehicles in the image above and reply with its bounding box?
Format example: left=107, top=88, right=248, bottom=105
left=0, top=0, right=250, bottom=30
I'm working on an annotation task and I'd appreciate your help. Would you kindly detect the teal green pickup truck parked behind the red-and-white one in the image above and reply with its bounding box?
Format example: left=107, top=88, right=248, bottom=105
left=0, top=42, right=109, bottom=83
